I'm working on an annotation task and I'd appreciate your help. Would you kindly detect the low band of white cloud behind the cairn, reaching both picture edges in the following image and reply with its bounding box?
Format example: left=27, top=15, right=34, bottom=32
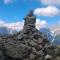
left=0, top=19, right=60, bottom=35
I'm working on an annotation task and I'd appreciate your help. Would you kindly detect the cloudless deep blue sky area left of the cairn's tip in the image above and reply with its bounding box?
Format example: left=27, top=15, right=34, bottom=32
left=0, top=0, right=41, bottom=22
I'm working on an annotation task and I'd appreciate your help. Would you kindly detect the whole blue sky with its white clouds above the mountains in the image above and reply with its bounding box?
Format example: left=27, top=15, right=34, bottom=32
left=0, top=0, right=60, bottom=29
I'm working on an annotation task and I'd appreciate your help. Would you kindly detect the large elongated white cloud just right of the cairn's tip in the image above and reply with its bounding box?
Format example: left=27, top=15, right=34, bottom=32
left=34, top=6, right=60, bottom=16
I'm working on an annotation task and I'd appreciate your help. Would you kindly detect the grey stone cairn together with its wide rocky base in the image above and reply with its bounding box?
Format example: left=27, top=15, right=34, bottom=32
left=0, top=11, right=58, bottom=60
